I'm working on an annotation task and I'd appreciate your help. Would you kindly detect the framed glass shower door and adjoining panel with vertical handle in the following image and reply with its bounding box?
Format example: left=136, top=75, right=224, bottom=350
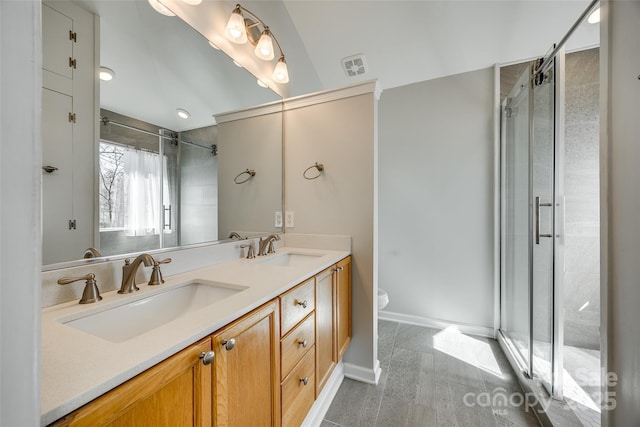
left=501, top=58, right=562, bottom=397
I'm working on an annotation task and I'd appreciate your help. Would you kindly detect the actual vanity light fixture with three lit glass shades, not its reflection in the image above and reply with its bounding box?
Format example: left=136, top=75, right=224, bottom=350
left=224, top=4, right=289, bottom=83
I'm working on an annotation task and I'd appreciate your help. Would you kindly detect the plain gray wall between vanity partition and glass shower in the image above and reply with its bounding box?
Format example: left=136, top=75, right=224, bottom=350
left=379, top=69, right=495, bottom=328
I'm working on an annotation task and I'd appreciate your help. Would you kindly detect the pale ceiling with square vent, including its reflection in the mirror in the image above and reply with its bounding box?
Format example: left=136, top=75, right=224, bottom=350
left=76, top=0, right=599, bottom=131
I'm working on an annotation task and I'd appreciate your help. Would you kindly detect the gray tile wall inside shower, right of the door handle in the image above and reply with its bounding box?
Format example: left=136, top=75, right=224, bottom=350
left=564, top=48, right=600, bottom=349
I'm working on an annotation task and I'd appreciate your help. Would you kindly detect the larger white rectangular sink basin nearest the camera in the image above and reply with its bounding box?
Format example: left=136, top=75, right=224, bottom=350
left=58, top=280, right=247, bottom=343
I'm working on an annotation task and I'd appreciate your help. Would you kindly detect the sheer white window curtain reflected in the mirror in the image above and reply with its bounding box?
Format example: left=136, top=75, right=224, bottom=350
left=124, top=150, right=161, bottom=236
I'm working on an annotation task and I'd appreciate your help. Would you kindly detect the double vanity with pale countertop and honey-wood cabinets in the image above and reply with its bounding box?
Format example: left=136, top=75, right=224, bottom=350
left=41, top=242, right=351, bottom=426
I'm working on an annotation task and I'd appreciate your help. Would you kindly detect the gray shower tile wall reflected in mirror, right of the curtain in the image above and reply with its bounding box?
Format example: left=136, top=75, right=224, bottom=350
left=180, top=126, right=218, bottom=245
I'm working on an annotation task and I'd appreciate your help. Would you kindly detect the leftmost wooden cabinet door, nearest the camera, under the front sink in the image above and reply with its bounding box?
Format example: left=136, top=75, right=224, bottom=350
left=53, top=338, right=212, bottom=427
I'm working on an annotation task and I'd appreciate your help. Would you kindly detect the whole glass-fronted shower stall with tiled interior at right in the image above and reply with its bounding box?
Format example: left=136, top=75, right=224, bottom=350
left=499, top=1, right=601, bottom=425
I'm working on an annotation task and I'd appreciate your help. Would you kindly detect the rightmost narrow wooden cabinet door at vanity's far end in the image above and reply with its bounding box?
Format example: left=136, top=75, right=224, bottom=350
left=334, top=256, right=351, bottom=362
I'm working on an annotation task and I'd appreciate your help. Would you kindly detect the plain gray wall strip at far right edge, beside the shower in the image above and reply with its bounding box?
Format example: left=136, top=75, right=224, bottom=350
left=600, top=1, right=640, bottom=426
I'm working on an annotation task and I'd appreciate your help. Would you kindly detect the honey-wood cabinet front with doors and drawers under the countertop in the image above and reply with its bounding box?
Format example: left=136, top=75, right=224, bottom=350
left=52, top=257, right=351, bottom=427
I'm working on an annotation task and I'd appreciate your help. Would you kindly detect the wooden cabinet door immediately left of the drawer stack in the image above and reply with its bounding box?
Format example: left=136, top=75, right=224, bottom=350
left=213, top=300, right=280, bottom=426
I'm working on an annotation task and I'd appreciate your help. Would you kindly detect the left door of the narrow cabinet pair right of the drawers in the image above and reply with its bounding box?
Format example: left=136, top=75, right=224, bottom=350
left=316, top=267, right=336, bottom=398
